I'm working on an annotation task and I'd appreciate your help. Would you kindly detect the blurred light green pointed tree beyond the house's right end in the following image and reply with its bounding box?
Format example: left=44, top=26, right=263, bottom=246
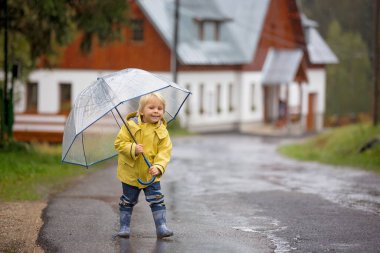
left=326, top=20, right=373, bottom=115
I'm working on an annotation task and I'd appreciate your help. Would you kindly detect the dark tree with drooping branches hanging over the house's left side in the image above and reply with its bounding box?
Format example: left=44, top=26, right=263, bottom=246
left=0, top=0, right=128, bottom=145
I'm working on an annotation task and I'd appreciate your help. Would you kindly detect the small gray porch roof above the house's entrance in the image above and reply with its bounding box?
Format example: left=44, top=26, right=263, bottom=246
left=262, top=48, right=303, bottom=85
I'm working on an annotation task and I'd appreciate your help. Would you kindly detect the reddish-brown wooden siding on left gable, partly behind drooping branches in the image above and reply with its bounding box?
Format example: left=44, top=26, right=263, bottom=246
left=57, top=2, right=170, bottom=71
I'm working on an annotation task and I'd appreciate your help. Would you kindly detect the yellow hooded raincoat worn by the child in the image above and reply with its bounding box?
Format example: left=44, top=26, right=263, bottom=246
left=115, top=112, right=172, bottom=188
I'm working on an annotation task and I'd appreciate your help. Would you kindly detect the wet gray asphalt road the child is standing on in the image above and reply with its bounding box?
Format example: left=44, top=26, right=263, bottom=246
left=39, top=134, right=380, bottom=253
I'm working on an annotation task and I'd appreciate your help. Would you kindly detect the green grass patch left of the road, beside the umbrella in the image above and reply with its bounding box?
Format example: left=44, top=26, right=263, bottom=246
left=0, top=144, right=90, bottom=201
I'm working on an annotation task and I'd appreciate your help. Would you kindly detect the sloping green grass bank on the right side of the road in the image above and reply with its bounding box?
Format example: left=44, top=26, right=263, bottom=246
left=279, top=124, right=380, bottom=172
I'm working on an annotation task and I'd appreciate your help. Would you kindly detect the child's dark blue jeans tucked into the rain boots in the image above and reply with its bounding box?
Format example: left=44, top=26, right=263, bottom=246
left=119, top=182, right=166, bottom=212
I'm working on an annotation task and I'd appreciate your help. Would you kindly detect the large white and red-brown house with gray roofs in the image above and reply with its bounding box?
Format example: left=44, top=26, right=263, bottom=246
left=14, top=0, right=338, bottom=140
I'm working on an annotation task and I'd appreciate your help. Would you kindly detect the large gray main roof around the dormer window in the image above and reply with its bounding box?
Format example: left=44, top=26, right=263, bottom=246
left=138, top=0, right=269, bottom=65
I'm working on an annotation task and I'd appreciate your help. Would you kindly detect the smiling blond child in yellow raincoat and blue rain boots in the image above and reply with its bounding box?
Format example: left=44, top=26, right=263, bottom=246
left=115, top=93, right=173, bottom=238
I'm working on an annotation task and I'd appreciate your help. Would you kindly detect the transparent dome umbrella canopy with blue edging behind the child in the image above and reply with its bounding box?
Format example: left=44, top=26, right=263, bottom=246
left=62, top=69, right=191, bottom=167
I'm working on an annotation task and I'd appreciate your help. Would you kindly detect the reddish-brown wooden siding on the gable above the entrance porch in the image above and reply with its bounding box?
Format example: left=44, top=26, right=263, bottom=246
left=243, top=0, right=307, bottom=71
